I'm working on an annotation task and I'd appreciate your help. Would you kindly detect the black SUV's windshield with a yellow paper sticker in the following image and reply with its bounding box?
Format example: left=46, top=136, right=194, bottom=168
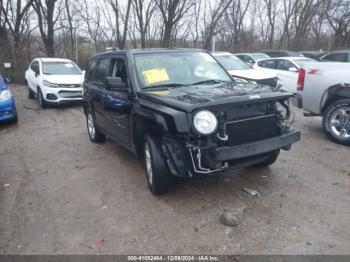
left=134, top=52, right=231, bottom=88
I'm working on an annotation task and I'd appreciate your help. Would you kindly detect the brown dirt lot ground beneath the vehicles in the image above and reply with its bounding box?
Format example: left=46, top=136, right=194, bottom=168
left=0, top=86, right=350, bottom=254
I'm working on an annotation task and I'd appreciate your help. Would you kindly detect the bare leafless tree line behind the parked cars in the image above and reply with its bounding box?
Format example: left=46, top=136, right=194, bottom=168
left=0, top=0, right=350, bottom=81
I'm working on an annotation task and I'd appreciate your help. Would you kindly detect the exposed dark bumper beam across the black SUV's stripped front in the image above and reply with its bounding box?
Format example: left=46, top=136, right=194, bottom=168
left=215, top=130, right=300, bottom=161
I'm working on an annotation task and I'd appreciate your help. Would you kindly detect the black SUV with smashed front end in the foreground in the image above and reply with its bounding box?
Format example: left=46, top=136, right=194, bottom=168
left=83, top=49, right=300, bottom=195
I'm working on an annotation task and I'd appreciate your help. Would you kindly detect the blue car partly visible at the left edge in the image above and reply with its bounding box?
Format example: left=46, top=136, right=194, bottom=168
left=0, top=76, right=17, bottom=122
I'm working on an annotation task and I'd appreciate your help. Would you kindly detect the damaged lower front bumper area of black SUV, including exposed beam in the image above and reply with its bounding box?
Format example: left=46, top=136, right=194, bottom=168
left=163, top=130, right=300, bottom=177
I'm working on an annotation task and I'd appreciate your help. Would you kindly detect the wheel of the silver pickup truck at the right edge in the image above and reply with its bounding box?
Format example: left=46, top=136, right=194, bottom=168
left=322, top=98, right=350, bottom=146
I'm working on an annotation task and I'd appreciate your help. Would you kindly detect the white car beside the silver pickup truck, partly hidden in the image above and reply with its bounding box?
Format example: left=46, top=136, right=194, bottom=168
left=254, top=57, right=315, bottom=93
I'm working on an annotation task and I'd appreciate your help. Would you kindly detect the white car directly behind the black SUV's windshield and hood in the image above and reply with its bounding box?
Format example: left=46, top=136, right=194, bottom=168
left=213, top=52, right=281, bottom=87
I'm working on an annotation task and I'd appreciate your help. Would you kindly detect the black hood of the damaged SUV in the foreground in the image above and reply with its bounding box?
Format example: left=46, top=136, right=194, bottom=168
left=138, top=82, right=292, bottom=112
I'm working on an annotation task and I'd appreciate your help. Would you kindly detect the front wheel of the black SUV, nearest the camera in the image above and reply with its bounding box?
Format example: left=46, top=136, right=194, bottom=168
left=144, top=135, right=175, bottom=195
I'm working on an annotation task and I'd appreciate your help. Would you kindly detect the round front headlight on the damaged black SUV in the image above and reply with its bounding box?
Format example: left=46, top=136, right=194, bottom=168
left=193, top=110, right=218, bottom=135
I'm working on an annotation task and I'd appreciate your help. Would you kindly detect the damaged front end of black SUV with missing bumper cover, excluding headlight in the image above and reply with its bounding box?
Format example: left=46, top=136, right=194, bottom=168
left=163, top=91, right=300, bottom=177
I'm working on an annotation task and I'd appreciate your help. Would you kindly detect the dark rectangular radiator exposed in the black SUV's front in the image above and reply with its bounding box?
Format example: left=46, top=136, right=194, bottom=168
left=226, top=115, right=279, bottom=146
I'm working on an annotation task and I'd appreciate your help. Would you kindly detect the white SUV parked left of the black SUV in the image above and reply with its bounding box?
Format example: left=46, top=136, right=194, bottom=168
left=25, top=58, right=84, bottom=108
